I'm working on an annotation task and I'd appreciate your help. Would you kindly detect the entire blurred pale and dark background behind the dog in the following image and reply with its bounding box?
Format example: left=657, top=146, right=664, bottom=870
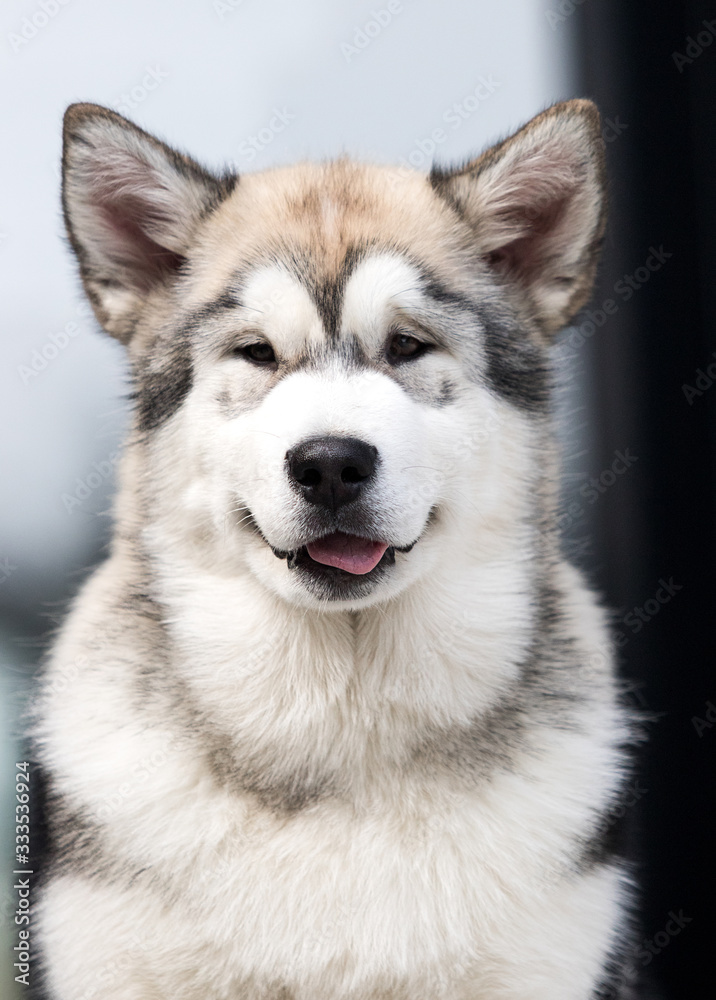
left=0, top=0, right=716, bottom=1000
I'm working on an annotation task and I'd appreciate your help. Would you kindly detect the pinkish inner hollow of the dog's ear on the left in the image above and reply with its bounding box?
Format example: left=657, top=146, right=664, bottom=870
left=86, top=151, right=184, bottom=292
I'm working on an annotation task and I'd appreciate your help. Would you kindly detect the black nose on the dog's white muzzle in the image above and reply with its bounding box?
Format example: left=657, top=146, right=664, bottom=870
left=286, top=437, right=378, bottom=510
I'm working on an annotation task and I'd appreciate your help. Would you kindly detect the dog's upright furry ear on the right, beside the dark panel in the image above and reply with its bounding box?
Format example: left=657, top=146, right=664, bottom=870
left=430, top=100, right=606, bottom=333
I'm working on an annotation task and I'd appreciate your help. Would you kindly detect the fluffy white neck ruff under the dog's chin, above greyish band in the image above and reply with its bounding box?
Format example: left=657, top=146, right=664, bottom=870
left=106, top=434, right=564, bottom=800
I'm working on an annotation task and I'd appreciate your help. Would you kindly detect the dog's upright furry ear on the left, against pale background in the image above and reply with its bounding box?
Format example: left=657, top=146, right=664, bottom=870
left=62, top=104, right=236, bottom=343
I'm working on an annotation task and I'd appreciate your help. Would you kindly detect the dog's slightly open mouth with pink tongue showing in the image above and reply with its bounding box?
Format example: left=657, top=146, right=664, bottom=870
left=271, top=531, right=415, bottom=577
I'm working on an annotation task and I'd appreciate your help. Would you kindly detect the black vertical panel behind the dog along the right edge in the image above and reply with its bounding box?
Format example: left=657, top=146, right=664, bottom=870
left=574, top=0, right=716, bottom=1000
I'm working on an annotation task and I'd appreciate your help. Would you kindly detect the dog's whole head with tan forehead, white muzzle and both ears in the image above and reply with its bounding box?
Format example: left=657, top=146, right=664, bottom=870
left=64, top=107, right=603, bottom=608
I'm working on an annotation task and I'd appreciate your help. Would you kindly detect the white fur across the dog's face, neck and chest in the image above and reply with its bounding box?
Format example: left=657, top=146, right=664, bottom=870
left=36, top=101, right=631, bottom=1000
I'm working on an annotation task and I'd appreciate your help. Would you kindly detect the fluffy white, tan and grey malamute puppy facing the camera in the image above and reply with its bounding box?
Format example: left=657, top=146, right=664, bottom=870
left=33, top=100, right=639, bottom=1000
